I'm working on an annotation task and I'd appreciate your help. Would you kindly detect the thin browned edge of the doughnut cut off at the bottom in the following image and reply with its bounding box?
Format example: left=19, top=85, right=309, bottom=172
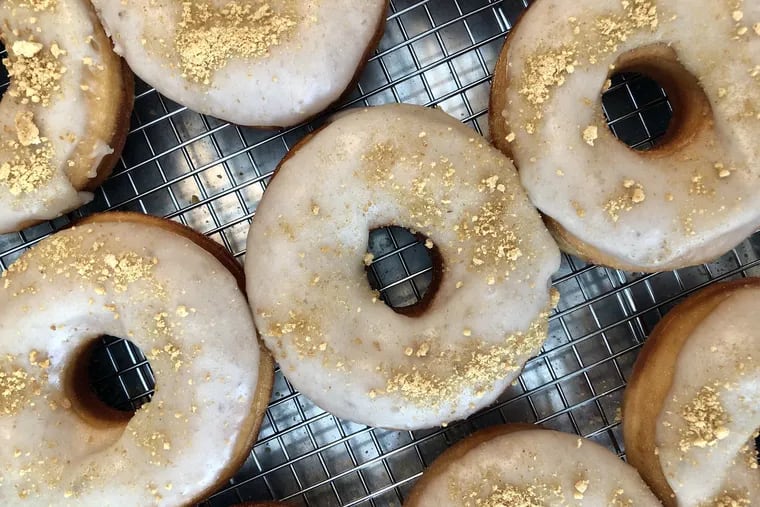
left=404, top=423, right=546, bottom=507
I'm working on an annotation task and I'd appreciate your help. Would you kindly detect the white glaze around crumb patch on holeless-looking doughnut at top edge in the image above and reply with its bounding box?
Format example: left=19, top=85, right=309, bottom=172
left=93, top=0, right=387, bottom=127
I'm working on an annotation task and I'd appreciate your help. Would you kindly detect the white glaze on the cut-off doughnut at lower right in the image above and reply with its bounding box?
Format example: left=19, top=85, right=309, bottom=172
left=655, top=288, right=760, bottom=506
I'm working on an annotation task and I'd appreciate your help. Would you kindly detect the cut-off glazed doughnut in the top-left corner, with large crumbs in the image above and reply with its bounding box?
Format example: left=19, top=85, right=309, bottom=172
left=0, top=0, right=134, bottom=233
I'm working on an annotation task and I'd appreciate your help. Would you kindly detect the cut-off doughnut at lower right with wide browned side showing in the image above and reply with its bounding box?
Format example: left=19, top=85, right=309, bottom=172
left=623, top=278, right=760, bottom=507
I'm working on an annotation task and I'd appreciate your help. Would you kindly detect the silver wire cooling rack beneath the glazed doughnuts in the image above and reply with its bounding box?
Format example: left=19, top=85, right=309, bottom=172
left=0, top=0, right=760, bottom=507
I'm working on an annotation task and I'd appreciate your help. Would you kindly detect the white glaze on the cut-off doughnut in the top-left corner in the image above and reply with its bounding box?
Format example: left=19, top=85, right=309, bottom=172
left=0, top=0, right=120, bottom=233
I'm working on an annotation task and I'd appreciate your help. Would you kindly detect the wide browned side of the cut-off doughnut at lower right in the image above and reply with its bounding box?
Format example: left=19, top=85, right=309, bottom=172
left=623, top=278, right=760, bottom=507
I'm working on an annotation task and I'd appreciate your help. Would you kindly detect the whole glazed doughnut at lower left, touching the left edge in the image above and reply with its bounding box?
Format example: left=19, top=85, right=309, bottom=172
left=0, top=213, right=273, bottom=506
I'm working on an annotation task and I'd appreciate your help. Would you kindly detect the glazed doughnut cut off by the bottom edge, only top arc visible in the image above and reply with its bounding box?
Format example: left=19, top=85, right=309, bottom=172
left=404, top=424, right=660, bottom=507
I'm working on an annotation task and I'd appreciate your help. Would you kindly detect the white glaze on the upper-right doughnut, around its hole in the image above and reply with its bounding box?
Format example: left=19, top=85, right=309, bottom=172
left=502, top=0, right=760, bottom=270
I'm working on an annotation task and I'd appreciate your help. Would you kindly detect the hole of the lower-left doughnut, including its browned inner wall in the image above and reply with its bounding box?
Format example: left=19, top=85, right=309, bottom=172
left=64, top=336, right=155, bottom=424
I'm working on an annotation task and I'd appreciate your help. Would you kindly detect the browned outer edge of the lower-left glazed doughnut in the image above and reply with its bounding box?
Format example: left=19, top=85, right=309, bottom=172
left=75, top=212, right=274, bottom=503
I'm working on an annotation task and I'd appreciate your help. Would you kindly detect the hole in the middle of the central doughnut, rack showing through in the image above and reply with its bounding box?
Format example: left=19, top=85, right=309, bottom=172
left=365, top=226, right=443, bottom=317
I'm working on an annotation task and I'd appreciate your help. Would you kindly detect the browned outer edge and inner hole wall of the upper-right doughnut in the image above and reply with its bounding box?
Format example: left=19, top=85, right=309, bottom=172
left=488, top=0, right=714, bottom=272
